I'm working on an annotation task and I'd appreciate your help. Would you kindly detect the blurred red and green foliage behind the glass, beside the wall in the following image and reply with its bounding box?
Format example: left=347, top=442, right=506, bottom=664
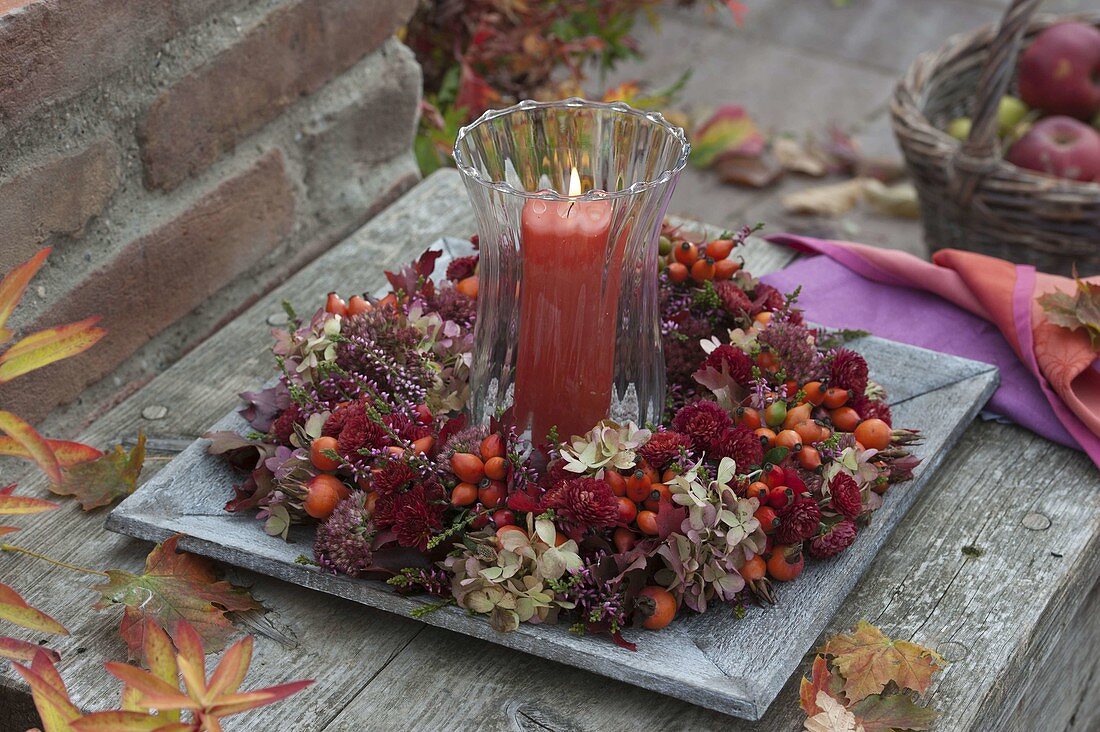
left=405, top=0, right=745, bottom=175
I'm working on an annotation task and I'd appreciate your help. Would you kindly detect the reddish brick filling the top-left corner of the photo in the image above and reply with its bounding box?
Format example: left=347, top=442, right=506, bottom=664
left=0, top=0, right=221, bottom=124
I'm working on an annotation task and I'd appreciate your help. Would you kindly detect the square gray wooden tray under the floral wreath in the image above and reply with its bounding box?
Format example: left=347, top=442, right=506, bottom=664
left=107, top=338, right=998, bottom=720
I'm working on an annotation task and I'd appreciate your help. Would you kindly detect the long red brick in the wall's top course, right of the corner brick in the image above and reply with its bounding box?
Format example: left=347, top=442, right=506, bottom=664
left=138, top=0, right=416, bottom=190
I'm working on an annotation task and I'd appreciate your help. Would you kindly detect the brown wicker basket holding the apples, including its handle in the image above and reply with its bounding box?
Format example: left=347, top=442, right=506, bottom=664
left=891, top=0, right=1100, bottom=275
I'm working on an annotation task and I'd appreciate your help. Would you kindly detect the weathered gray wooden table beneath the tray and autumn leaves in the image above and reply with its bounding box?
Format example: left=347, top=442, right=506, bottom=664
left=0, top=171, right=1100, bottom=732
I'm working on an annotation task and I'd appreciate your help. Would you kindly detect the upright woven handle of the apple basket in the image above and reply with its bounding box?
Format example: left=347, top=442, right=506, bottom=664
left=950, top=0, right=1043, bottom=201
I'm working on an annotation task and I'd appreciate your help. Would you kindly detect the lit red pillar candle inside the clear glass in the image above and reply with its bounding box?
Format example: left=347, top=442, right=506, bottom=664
left=515, top=171, right=623, bottom=443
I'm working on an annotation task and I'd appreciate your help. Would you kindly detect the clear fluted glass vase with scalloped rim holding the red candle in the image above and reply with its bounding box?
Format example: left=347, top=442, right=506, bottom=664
left=454, top=99, right=689, bottom=443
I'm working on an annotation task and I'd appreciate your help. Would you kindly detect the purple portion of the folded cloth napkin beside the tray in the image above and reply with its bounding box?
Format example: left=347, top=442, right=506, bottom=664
left=761, top=255, right=1080, bottom=449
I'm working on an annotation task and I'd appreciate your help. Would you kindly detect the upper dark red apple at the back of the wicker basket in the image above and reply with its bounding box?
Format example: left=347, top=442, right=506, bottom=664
left=1018, top=23, right=1100, bottom=119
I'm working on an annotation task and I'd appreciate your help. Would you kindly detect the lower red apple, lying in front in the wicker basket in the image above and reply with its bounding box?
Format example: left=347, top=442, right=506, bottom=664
left=1005, top=117, right=1100, bottom=181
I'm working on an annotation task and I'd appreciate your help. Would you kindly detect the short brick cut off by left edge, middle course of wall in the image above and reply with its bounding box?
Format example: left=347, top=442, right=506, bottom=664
left=0, top=140, right=119, bottom=274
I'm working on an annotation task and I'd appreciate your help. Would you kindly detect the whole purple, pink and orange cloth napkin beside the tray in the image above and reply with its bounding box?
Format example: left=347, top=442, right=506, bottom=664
left=765, top=234, right=1100, bottom=466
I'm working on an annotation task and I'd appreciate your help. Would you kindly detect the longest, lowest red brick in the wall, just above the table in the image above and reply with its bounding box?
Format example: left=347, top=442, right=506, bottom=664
left=0, top=151, right=295, bottom=419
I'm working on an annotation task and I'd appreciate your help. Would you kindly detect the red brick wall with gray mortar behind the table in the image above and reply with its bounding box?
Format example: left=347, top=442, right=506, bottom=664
left=0, top=0, right=420, bottom=418
